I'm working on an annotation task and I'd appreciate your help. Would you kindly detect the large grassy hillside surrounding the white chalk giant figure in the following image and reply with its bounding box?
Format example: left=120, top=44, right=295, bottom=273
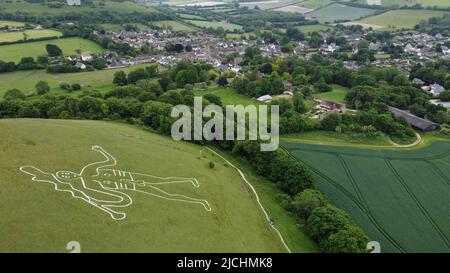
left=0, top=119, right=298, bottom=252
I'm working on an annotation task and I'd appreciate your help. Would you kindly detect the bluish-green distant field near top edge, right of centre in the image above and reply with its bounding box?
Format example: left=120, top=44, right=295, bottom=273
left=305, top=4, right=377, bottom=23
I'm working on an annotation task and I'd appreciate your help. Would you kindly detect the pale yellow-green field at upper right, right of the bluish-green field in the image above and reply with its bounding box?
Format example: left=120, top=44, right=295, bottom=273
left=357, top=10, right=445, bottom=29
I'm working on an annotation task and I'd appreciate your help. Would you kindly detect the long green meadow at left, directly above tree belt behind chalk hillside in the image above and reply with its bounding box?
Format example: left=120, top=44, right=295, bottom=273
left=0, top=64, right=148, bottom=96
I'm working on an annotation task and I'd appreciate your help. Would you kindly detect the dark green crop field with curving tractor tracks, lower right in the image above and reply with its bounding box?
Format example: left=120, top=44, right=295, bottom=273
left=282, top=141, right=450, bottom=252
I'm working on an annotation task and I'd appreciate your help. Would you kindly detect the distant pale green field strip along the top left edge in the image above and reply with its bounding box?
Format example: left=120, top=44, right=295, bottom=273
left=0, top=0, right=155, bottom=14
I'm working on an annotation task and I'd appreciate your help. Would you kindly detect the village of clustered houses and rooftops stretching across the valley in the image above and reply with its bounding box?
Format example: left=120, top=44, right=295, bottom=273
left=1, top=19, right=450, bottom=119
